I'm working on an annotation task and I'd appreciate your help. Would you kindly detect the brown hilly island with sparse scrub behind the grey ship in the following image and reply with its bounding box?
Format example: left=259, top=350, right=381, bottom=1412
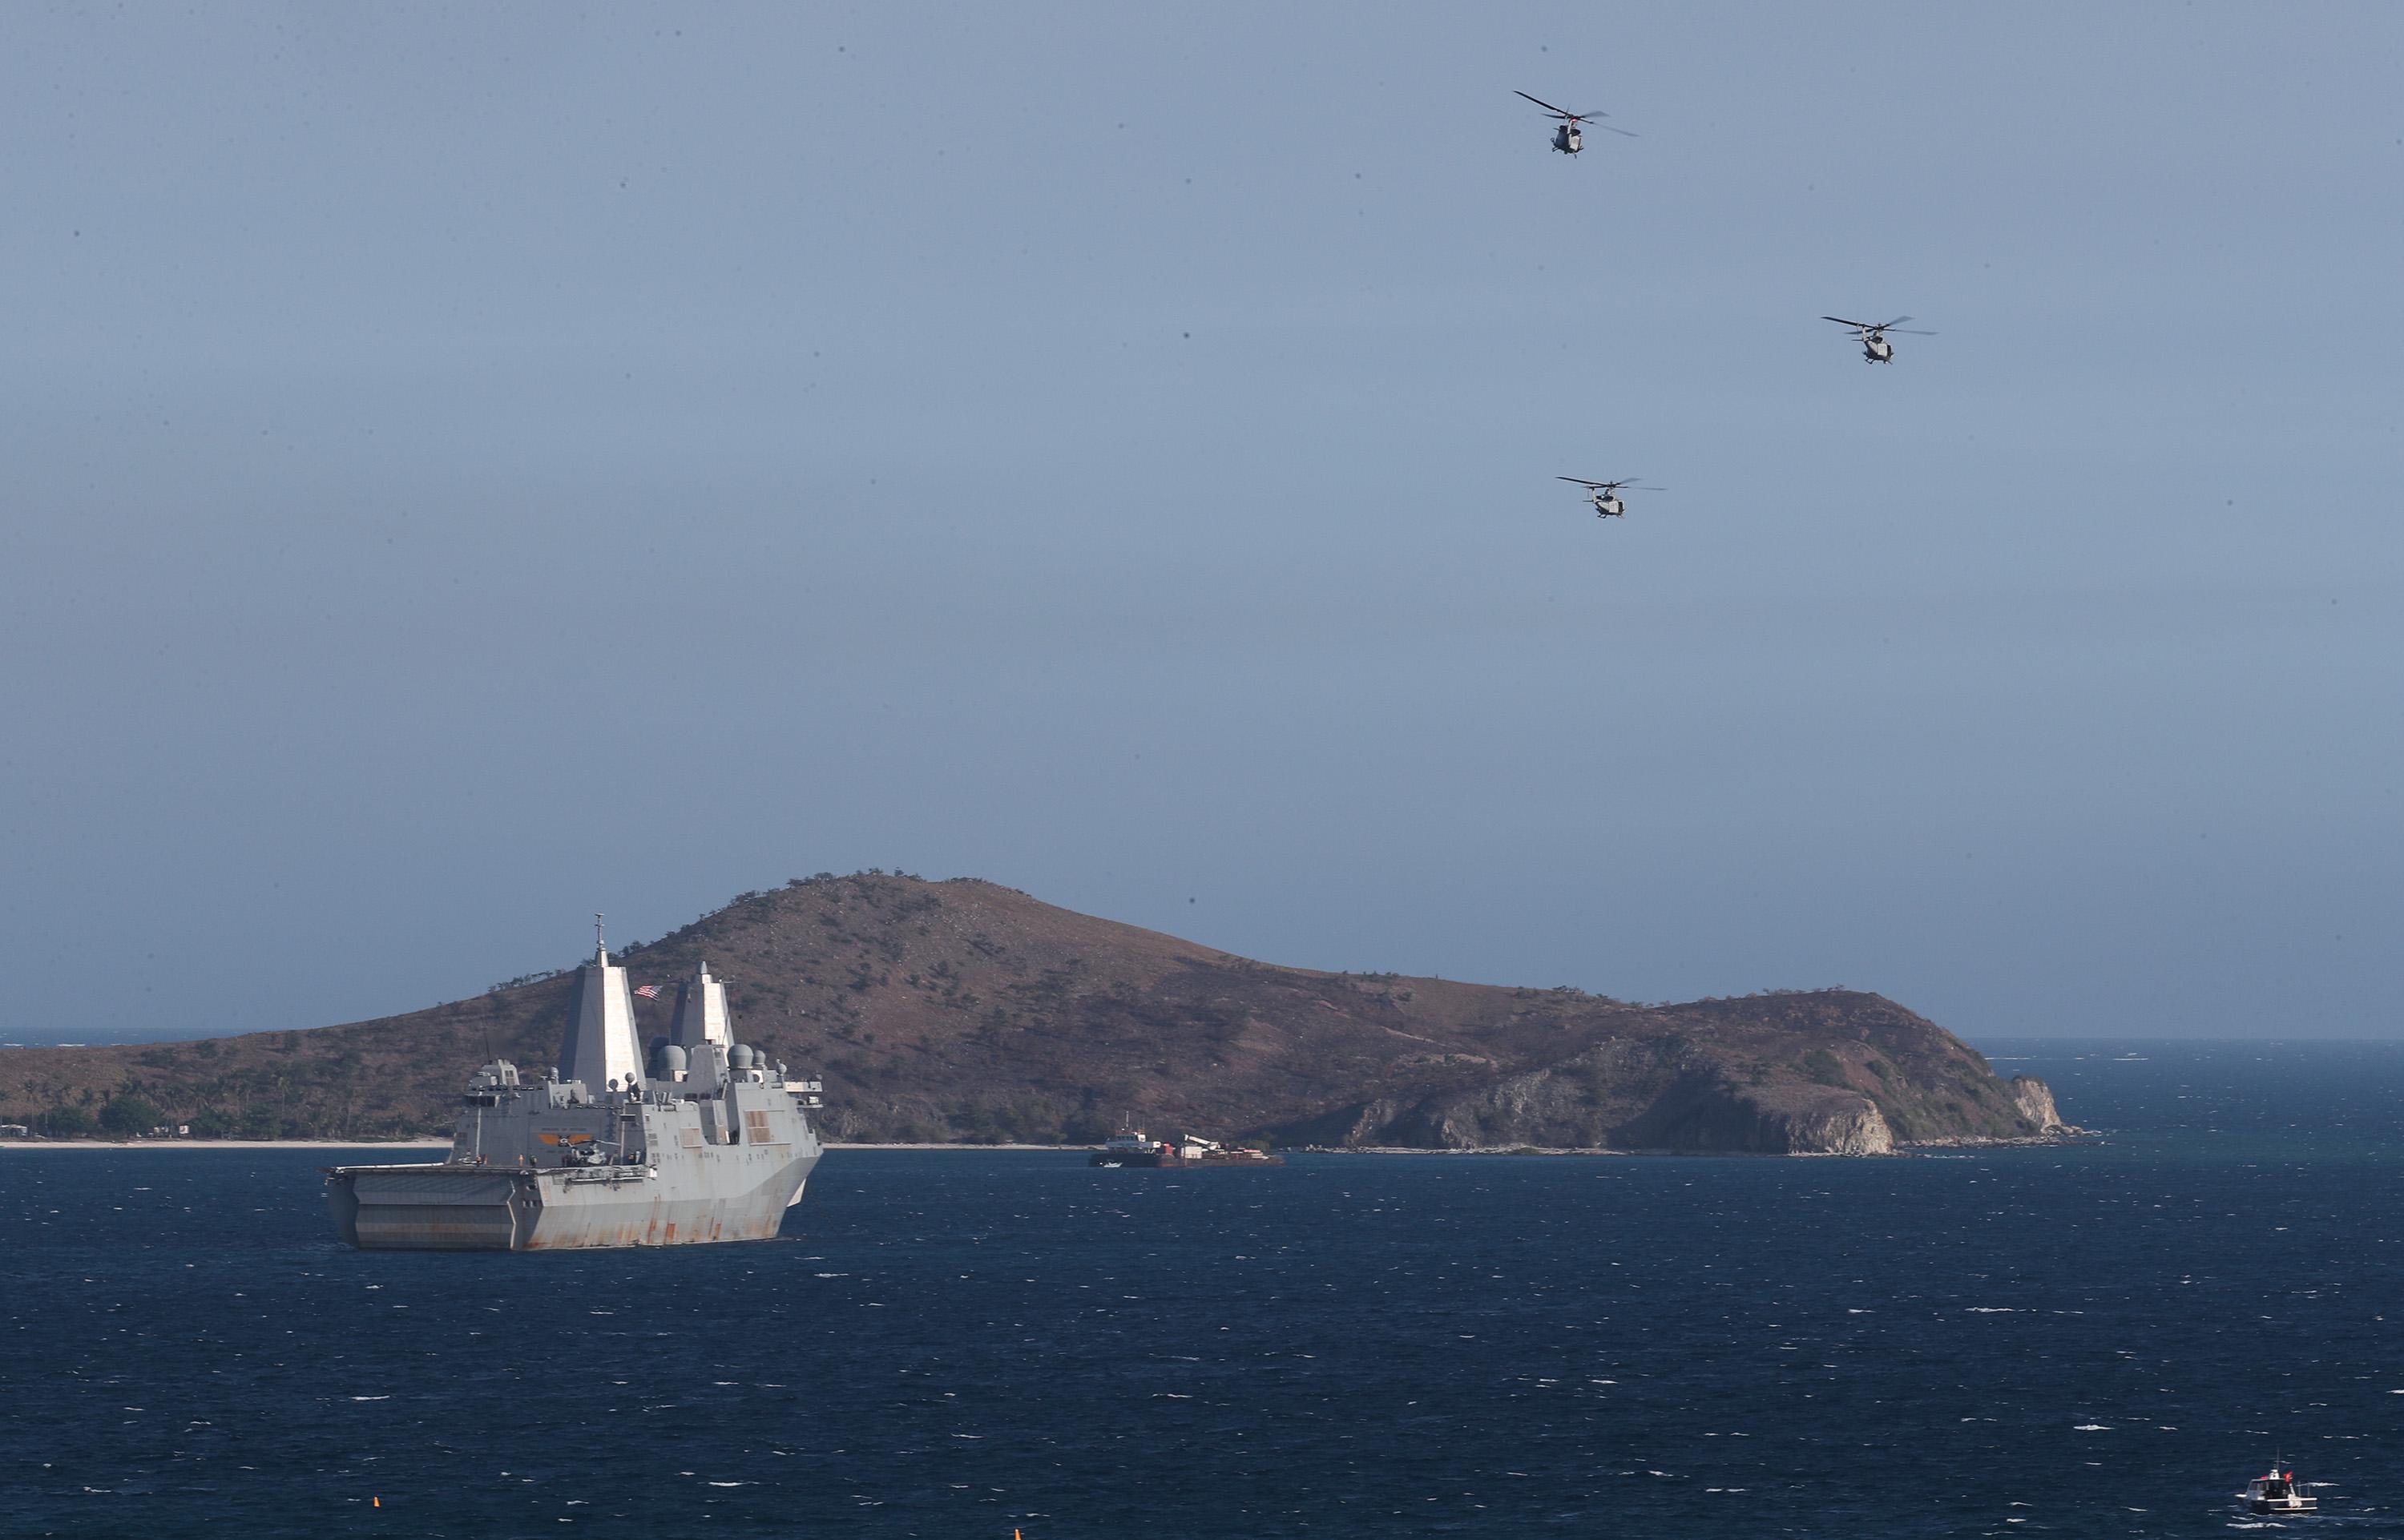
left=0, top=872, right=2065, bottom=1155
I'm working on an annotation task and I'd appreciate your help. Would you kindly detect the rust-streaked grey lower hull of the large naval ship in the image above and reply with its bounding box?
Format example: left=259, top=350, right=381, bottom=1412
left=325, top=1141, right=817, bottom=1252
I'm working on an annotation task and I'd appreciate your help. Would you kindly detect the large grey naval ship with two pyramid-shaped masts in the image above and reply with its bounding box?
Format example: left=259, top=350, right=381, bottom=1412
left=325, top=944, right=820, bottom=1252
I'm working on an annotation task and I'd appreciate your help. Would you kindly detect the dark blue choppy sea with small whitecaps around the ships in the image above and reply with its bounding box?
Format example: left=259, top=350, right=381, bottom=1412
left=0, top=1042, right=2404, bottom=1540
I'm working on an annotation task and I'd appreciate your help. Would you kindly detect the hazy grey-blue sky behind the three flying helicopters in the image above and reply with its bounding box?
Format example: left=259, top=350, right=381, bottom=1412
left=0, top=0, right=2404, bottom=1040
